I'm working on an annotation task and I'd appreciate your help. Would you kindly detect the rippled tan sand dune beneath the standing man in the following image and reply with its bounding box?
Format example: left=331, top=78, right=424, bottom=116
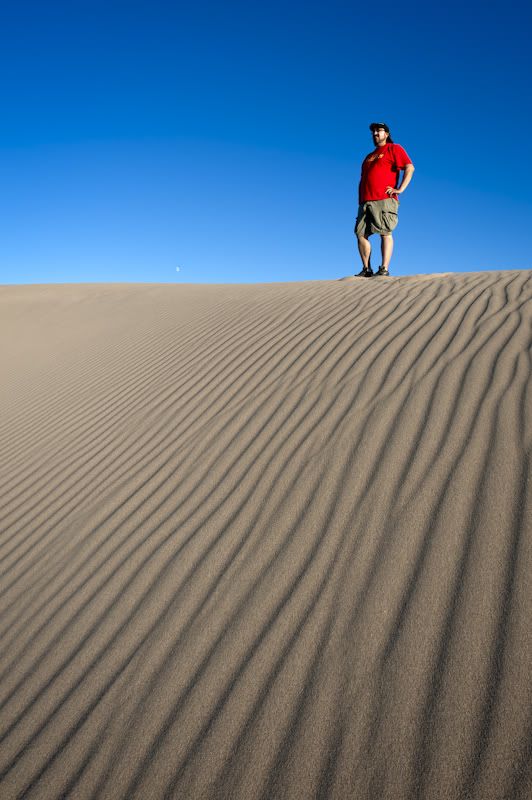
left=0, top=271, right=532, bottom=800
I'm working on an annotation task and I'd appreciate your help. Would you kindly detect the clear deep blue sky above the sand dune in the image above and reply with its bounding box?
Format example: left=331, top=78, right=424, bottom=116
left=0, top=0, right=532, bottom=283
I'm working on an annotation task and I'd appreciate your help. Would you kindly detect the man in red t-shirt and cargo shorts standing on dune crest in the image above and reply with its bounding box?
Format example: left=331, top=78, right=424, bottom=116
left=355, top=122, right=414, bottom=278
